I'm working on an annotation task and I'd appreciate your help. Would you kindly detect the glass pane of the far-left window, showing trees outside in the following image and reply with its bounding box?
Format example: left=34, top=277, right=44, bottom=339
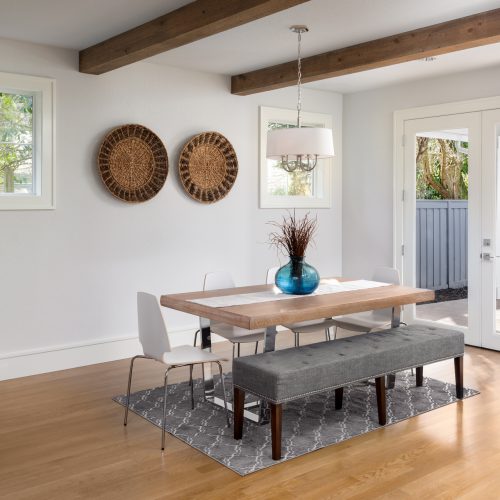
left=0, top=92, right=34, bottom=195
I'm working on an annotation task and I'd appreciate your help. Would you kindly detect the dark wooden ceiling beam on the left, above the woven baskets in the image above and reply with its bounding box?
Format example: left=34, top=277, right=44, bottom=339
left=80, top=0, right=309, bottom=75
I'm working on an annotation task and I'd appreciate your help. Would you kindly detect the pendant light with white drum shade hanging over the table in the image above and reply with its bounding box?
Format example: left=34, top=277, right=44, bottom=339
left=266, top=26, right=334, bottom=172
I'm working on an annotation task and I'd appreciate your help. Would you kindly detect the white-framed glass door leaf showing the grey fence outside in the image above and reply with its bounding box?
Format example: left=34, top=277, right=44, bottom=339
left=403, top=113, right=481, bottom=345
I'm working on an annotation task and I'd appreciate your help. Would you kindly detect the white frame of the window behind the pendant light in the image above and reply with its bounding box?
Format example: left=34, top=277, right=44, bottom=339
left=259, top=106, right=333, bottom=208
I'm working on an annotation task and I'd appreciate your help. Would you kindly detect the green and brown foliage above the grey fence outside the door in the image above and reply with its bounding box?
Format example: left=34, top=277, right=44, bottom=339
left=416, top=137, right=469, bottom=200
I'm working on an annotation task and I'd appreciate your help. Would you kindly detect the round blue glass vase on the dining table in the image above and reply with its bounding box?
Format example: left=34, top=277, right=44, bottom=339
left=275, top=256, right=319, bottom=295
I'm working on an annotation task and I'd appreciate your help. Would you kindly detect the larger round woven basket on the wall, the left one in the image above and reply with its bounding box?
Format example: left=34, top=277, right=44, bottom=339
left=97, top=125, right=168, bottom=203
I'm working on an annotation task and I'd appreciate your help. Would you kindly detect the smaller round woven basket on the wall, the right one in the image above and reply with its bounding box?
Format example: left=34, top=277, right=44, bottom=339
left=179, top=132, right=238, bottom=203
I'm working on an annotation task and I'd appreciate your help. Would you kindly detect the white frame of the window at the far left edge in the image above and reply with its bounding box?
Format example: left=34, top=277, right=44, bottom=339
left=0, top=73, right=56, bottom=210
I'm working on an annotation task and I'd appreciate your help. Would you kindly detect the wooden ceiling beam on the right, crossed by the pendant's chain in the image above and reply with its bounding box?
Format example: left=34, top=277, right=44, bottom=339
left=231, top=9, right=500, bottom=95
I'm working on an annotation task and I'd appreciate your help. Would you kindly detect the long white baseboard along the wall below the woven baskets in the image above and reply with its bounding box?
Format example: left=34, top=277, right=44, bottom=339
left=0, top=327, right=224, bottom=380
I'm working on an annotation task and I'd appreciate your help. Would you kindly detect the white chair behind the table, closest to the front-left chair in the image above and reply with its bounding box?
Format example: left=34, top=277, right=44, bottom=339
left=194, top=271, right=265, bottom=358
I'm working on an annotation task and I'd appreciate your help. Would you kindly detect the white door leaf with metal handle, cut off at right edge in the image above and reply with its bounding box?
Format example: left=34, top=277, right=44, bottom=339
left=479, top=109, right=500, bottom=350
